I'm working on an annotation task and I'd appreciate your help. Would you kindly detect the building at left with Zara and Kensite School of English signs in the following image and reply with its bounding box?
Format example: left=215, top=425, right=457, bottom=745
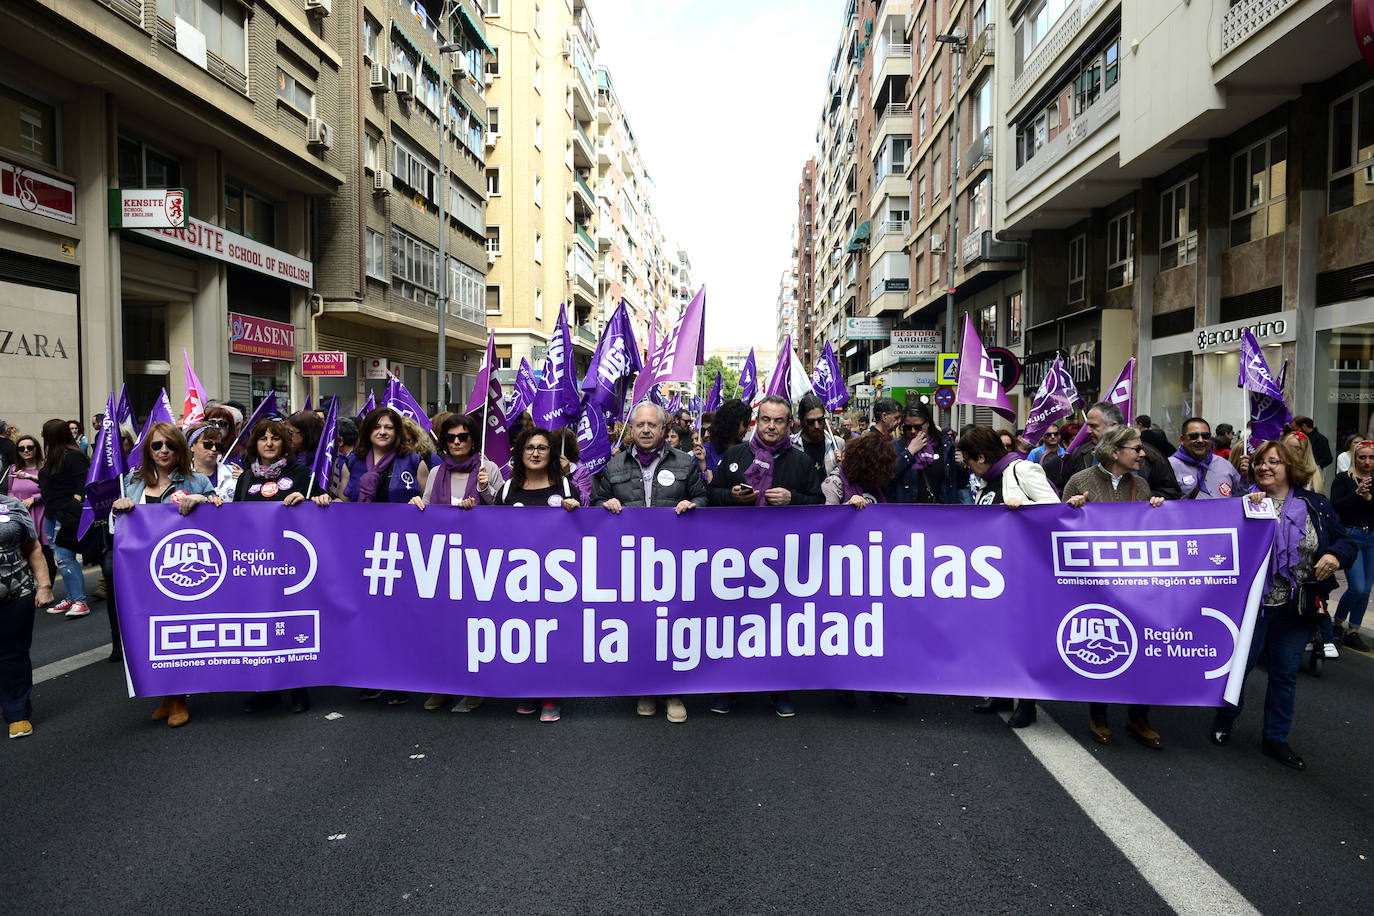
left=0, top=0, right=356, bottom=430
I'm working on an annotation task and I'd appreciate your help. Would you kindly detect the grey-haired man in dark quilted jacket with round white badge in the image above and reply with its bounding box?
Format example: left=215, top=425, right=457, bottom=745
left=592, top=401, right=706, bottom=722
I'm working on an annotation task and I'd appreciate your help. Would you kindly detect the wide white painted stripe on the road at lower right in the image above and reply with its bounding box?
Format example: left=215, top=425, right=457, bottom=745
left=1014, top=709, right=1260, bottom=915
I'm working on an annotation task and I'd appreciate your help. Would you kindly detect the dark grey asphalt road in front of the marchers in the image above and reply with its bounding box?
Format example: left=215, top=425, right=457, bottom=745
left=0, top=576, right=1374, bottom=915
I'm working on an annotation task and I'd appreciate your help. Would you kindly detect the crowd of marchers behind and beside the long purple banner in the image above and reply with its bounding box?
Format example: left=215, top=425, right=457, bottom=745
left=0, top=394, right=1374, bottom=769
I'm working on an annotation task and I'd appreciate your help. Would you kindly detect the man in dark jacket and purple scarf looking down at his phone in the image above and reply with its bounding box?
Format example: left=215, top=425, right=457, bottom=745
left=706, top=394, right=824, bottom=718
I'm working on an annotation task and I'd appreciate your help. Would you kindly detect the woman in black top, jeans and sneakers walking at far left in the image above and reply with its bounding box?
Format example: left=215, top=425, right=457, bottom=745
left=38, top=420, right=91, bottom=618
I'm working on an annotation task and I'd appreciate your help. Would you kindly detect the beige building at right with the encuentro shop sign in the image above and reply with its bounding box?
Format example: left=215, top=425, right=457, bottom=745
left=993, top=0, right=1374, bottom=442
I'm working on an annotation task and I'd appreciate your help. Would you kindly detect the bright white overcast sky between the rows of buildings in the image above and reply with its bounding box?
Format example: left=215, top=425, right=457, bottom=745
left=588, top=0, right=846, bottom=347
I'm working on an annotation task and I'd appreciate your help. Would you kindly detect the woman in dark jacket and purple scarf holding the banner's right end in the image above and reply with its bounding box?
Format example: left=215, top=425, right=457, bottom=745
left=1212, top=441, right=1358, bottom=769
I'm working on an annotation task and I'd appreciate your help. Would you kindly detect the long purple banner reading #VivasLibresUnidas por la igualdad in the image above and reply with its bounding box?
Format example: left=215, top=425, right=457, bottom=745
left=114, top=500, right=1274, bottom=706
